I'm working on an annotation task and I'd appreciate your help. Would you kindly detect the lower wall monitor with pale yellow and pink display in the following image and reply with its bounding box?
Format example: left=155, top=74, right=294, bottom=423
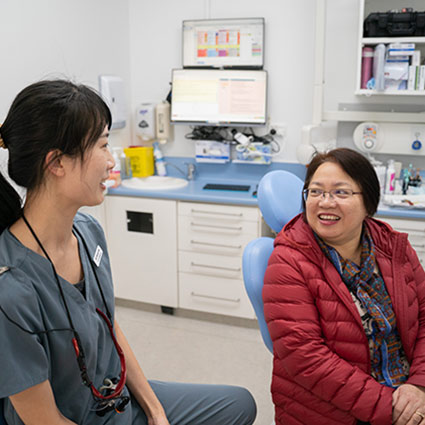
left=171, top=69, right=267, bottom=126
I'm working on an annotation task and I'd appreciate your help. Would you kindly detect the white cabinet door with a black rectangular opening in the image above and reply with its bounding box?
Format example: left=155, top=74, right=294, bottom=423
left=106, top=196, right=178, bottom=307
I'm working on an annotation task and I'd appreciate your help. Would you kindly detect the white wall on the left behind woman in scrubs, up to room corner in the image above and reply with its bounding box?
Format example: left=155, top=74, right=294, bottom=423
left=0, top=0, right=131, bottom=144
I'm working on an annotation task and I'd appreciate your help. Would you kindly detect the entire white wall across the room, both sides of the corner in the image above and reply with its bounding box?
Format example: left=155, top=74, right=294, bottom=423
left=0, top=0, right=423, bottom=162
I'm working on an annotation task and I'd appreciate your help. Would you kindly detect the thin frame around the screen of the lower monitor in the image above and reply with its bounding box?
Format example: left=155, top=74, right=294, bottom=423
left=170, top=68, right=269, bottom=127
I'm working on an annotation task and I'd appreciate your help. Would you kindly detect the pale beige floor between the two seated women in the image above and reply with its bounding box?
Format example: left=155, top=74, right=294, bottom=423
left=116, top=300, right=273, bottom=425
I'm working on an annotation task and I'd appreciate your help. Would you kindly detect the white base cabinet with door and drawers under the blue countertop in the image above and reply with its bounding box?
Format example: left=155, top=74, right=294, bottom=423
left=106, top=196, right=269, bottom=319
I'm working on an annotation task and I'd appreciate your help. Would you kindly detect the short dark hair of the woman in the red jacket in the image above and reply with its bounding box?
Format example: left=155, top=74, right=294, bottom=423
left=303, top=148, right=380, bottom=217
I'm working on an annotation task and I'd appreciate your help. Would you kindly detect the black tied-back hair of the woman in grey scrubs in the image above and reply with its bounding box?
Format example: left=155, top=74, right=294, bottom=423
left=0, top=80, right=112, bottom=233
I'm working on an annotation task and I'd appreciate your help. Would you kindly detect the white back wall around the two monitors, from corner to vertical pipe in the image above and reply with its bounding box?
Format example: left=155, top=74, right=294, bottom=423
left=129, top=0, right=315, bottom=162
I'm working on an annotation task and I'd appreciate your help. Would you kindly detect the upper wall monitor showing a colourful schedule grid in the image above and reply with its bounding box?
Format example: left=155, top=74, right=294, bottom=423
left=183, top=18, right=264, bottom=69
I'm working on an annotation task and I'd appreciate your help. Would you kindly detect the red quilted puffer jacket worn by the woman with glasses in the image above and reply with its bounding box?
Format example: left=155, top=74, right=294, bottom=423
left=263, top=214, right=425, bottom=425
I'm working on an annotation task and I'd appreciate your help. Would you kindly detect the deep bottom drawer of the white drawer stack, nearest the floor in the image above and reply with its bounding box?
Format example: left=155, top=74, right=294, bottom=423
left=179, top=273, right=255, bottom=319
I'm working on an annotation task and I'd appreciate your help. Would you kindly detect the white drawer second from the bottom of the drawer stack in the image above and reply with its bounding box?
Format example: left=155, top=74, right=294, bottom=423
left=179, top=251, right=242, bottom=279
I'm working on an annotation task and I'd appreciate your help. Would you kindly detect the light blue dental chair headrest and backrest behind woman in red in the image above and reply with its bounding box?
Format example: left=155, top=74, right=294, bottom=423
left=242, top=170, right=304, bottom=353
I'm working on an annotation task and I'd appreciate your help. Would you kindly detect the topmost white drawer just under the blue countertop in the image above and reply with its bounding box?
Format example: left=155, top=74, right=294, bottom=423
left=178, top=201, right=261, bottom=222
